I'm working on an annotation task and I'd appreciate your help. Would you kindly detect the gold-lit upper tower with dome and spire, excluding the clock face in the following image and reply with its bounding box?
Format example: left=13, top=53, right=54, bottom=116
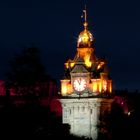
left=61, top=9, right=112, bottom=96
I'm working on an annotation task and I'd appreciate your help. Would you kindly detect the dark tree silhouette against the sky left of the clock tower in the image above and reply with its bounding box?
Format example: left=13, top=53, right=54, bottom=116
left=6, top=44, right=54, bottom=95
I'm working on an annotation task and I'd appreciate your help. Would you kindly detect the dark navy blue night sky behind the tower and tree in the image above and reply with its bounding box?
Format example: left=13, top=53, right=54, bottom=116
left=0, top=0, right=140, bottom=90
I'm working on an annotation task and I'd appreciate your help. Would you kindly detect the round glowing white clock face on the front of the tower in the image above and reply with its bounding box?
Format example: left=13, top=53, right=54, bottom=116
left=73, top=78, right=86, bottom=91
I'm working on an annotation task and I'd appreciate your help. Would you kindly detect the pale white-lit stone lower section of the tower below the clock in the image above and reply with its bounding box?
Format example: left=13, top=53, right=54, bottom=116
left=60, top=98, right=112, bottom=140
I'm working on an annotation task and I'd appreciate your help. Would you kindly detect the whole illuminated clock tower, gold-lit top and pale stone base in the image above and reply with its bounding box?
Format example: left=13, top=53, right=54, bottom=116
left=60, top=9, right=112, bottom=140
